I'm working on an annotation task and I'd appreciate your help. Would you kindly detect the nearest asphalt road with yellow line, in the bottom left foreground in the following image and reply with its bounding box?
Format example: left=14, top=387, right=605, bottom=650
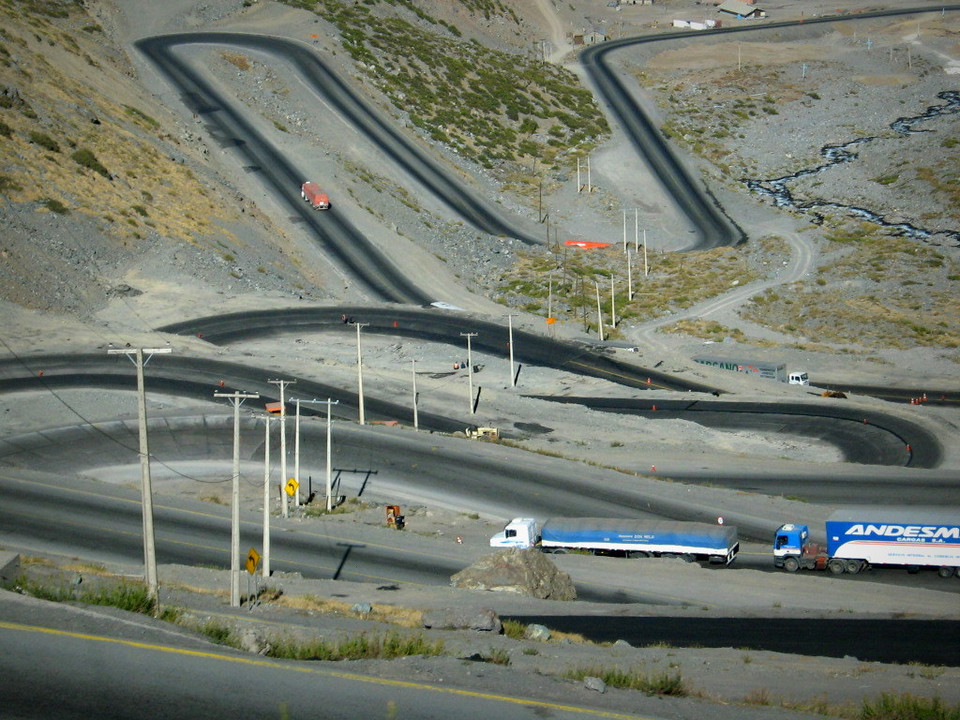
left=0, top=599, right=632, bottom=720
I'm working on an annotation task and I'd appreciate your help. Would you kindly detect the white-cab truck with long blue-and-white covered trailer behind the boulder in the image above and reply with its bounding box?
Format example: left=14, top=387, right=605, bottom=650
left=490, top=518, right=740, bottom=565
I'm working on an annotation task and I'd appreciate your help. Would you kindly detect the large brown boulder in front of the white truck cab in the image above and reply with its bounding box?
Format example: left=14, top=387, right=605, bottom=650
left=450, top=548, right=577, bottom=600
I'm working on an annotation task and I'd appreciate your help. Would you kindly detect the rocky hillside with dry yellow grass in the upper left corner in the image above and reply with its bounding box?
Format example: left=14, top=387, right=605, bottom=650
left=0, top=0, right=322, bottom=315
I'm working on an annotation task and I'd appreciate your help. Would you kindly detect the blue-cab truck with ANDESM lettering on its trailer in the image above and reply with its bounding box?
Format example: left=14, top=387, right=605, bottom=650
left=773, top=508, right=960, bottom=578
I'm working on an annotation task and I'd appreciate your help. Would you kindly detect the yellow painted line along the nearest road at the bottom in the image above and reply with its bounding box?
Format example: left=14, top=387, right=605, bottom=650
left=0, top=621, right=644, bottom=720
